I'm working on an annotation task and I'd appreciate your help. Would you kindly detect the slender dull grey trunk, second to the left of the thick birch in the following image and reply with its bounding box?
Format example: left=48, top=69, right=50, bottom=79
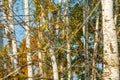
left=83, top=0, right=90, bottom=80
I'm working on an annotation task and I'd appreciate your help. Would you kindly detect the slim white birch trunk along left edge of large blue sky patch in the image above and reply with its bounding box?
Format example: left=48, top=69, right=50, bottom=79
left=8, top=0, right=18, bottom=69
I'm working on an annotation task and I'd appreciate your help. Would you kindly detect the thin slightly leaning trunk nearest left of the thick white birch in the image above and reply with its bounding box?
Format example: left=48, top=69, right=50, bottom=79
left=92, top=15, right=99, bottom=80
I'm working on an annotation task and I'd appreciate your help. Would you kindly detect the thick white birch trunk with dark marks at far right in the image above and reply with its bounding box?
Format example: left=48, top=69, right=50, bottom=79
left=102, top=0, right=119, bottom=80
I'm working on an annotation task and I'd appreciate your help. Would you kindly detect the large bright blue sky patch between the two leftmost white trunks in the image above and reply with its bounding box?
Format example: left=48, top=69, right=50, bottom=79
left=4, top=0, right=25, bottom=45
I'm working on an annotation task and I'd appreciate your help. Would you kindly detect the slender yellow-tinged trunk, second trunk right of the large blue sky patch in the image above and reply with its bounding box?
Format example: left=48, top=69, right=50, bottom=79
left=34, top=0, right=45, bottom=80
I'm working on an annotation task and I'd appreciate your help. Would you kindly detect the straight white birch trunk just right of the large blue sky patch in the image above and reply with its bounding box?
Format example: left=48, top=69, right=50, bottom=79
left=24, top=0, right=33, bottom=80
